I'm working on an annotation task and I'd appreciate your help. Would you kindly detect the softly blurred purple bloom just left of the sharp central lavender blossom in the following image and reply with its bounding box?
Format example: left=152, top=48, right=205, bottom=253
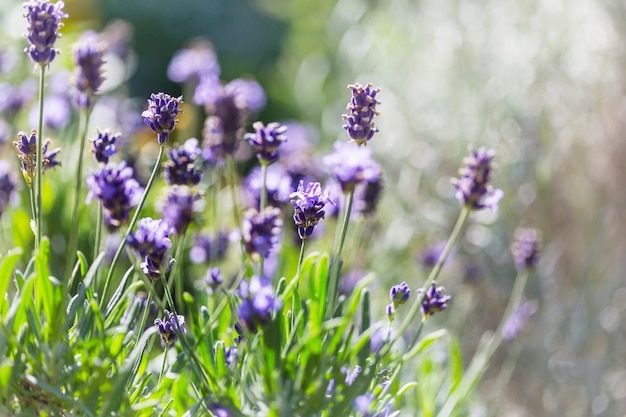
left=241, top=206, right=283, bottom=261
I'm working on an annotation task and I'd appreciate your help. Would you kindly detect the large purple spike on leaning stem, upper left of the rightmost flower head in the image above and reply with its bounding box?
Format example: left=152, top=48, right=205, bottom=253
left=452, top=148, right=503, bottom=212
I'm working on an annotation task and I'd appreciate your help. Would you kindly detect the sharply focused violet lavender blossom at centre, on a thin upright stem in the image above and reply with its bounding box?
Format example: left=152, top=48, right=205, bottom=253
left=291, top=181, right=334, bottom=240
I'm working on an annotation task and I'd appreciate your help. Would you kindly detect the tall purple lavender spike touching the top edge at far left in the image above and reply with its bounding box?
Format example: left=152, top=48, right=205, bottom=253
left=24, top=0, right=67, bottom=66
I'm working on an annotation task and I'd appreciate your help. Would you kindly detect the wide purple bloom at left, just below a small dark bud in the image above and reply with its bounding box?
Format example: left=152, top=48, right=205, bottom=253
left=87, top=163, right=142, bottom=229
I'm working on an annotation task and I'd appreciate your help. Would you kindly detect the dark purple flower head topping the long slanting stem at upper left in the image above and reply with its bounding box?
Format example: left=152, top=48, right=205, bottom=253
left=141, top=93, right=183, bottom=145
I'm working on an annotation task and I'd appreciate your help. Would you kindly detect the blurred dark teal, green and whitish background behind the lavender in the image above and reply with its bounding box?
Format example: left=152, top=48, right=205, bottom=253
left=0, top=0, right=626, bottom=416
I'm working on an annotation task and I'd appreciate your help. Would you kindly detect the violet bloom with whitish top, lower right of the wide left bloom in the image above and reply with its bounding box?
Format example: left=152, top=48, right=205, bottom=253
left=127, top=217, right=172, bottom=281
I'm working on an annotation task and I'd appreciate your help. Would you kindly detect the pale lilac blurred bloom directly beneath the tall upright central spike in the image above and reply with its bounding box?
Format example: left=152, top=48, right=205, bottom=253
left=324, top=142, right=380, bottom=193
